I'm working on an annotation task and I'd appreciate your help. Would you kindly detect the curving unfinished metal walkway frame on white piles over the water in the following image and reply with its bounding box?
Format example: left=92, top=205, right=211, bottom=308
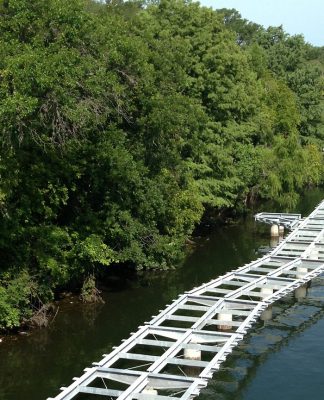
left=48, top=201, right=324, bottom=400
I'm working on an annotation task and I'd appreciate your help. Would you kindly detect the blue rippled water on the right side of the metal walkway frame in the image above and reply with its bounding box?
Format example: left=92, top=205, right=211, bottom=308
left=198, top=278, right=324, bottom=400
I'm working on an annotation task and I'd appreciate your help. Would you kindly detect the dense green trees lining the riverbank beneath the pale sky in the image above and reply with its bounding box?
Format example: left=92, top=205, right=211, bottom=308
left=0, top=0, right=324, bottom=329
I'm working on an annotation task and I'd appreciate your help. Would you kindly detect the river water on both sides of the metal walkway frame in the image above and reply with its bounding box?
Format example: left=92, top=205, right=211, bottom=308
left=0, top=190, right=324, bottom=400
